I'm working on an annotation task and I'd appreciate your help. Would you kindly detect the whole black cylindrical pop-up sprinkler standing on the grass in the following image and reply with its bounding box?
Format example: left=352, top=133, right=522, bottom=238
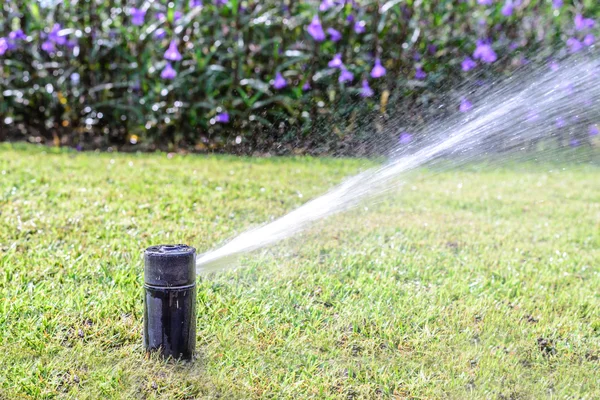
left=144, top=244, right=196, bottom=360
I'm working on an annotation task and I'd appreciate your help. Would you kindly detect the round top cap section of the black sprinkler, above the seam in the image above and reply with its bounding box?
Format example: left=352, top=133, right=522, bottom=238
left=144, top=244, right=196, bottom=287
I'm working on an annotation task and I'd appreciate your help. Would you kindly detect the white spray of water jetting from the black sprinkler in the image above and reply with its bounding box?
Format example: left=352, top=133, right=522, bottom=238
left=197, top=59, right=600, bottom=274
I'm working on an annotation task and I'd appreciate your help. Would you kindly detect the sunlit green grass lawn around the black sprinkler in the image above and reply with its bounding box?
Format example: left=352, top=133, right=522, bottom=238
left=0, top=145, right=600, bottom=399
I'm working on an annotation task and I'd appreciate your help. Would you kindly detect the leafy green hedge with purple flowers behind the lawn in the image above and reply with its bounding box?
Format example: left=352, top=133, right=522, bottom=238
left=0, top=0, right=600, bottom=150
